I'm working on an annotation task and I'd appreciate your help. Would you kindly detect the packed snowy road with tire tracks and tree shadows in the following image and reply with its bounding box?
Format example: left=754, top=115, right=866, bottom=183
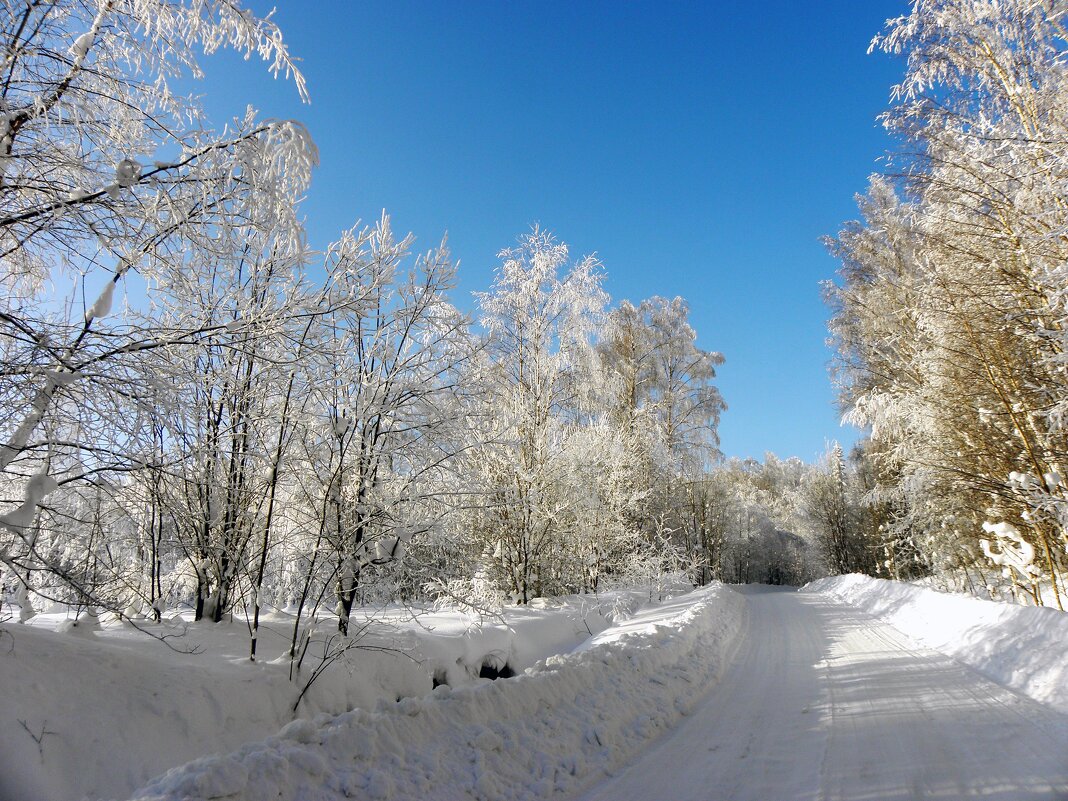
left=581, top=586, right=1068, bottom=801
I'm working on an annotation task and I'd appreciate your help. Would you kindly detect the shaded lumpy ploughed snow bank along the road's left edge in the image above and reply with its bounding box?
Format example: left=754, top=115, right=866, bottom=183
left=127, top=585, right=744, bottom=801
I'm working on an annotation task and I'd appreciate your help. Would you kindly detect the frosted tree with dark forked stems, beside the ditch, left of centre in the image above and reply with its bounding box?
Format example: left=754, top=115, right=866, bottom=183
left=299, top=217, right=473, bottom=633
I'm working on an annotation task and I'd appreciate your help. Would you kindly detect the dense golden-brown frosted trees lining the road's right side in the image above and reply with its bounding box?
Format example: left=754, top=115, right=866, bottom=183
left=828, top=0, right=1068, bottom=604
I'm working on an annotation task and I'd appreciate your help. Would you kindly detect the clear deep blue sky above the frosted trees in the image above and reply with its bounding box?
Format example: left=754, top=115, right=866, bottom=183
left=203, top=0, right=907, bottom=460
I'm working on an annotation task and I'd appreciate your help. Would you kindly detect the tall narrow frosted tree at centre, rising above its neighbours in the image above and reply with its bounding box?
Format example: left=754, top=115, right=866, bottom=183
left=472, top=229, right=608, bottom=602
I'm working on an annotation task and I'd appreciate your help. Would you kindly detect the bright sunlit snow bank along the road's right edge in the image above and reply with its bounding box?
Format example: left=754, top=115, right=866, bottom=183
left=803, top=575, right=1068, bottom=712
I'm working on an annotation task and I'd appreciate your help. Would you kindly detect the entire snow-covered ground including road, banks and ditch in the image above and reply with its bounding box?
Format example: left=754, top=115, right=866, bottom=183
left=0, top=576, right=1068, bottom=801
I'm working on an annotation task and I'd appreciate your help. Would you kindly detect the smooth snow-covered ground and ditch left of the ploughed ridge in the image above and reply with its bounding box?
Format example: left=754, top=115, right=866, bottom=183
left=0, top=591, right=662, bottom=801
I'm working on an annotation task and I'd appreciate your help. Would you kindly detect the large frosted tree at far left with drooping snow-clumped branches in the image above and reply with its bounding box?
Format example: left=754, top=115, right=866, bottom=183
left=0, top=0, right=316, bottom=615
